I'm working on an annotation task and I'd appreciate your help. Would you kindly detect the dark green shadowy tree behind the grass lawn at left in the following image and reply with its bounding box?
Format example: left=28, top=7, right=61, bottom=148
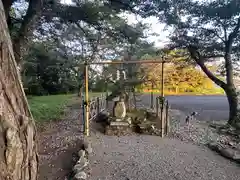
left=22, top=41, right=78, bottom=95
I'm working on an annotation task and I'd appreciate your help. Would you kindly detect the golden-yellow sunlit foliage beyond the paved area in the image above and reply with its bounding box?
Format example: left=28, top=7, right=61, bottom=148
left=138, top=63, right=223, bottom=94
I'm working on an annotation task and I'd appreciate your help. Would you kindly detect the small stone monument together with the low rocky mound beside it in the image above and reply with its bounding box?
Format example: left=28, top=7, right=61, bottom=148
left=104, top=93, right=169, bottom=136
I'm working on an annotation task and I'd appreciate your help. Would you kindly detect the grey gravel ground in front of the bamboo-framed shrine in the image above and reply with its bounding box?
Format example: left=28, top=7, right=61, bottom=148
left=90, top=110, right=240, bottom=180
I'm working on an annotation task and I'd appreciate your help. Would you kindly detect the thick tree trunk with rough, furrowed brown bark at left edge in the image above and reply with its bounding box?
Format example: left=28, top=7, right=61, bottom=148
left=0, top=1, right=38, bottom=180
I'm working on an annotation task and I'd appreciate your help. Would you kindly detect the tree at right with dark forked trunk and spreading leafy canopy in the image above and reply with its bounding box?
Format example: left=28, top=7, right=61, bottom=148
left=116, top=0, right=240, bottom=125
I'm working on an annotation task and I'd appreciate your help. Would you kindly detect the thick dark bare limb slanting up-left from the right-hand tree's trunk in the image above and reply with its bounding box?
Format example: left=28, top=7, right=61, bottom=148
left=188, top=45, right=226, bottom=89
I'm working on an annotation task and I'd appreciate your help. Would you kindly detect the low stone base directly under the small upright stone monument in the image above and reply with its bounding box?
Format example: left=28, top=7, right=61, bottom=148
left=105, top=121, right=133, bottom=136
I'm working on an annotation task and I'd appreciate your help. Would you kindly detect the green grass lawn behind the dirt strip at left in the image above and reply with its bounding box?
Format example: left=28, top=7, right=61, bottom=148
left=28, top=93, right=101, bottom=123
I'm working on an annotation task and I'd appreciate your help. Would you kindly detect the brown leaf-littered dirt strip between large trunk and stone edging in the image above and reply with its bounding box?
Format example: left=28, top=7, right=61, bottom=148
left=39, top=99, right=82, bottom=180
